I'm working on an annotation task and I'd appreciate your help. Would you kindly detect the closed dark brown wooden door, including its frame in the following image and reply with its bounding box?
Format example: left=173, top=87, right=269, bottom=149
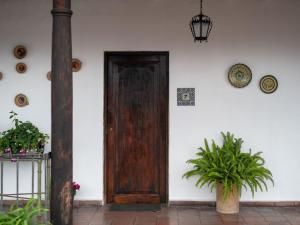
left=105, top=52, right=169, bottom=203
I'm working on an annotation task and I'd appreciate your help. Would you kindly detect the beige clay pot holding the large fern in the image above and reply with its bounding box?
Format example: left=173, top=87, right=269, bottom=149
left=217, top=183, right=240, bottom=214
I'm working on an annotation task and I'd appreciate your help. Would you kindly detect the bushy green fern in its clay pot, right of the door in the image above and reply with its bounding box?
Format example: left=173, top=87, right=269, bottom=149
left=183, top=132, right=274, bottom=214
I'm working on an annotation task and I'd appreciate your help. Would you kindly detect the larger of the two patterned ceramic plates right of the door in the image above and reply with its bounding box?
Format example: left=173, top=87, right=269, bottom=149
left=228, top=63, right=252, bottom=88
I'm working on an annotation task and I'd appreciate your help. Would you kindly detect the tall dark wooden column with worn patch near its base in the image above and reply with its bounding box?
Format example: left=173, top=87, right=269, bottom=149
left=50, top=0, right=73, bottom=225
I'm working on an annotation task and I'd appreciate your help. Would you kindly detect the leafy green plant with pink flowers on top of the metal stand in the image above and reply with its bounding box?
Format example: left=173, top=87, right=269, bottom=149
left=0, top=111, right=49, bottom=154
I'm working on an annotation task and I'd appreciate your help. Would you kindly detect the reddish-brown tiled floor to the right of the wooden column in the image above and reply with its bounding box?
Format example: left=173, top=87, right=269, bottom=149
left=73, top=206, right=300, bottom=225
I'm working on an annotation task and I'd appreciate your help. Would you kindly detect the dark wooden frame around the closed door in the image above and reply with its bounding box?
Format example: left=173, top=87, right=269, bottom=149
left=103, top=51, right=170, bottom=204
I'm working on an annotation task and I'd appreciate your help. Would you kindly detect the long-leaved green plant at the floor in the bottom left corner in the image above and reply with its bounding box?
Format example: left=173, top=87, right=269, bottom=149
left=0, top=199, right=51, bottom=225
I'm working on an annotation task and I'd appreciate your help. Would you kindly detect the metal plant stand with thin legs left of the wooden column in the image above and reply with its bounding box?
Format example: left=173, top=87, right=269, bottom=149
left=0, top=153, right=51, bottom=211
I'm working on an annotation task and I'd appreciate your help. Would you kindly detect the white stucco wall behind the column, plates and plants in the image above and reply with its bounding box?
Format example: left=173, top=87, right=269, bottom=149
left=0, top=0, right=300, bottom=201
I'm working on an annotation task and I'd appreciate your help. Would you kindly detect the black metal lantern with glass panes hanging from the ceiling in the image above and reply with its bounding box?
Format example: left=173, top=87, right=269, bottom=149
left=190, top=0, right=212, bottom=42
